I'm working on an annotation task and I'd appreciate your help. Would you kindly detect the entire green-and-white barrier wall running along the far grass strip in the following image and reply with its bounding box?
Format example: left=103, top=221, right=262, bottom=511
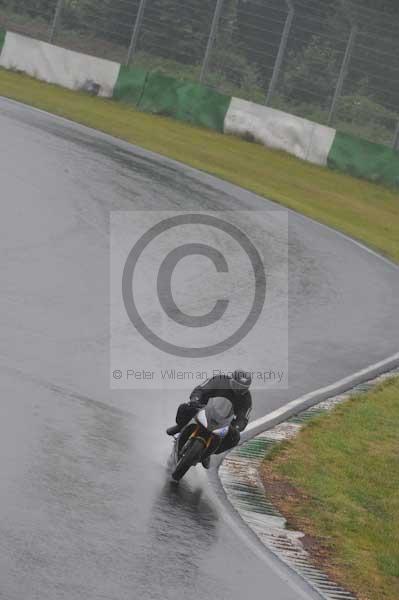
left=0, top=31, right=399, bottom=187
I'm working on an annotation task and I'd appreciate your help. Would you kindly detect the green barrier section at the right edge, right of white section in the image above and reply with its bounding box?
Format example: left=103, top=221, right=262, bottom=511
left=327, top=131, right=399, bottom=186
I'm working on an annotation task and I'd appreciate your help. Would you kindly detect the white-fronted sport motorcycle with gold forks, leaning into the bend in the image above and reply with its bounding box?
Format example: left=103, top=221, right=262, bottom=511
left=172, top=398, right=234, bottom=481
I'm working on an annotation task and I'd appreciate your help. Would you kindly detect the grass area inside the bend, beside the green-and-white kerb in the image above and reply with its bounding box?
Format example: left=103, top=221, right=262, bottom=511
left=264, top=378, right=399, bottom=600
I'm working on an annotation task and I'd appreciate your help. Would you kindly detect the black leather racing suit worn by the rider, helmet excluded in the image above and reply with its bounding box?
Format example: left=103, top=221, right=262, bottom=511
left=176, top=375, right=252, bottom=454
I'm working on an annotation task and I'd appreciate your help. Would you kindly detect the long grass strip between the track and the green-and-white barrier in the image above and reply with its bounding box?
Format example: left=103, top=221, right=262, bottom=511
left=0, top=69, right=399, bottom=261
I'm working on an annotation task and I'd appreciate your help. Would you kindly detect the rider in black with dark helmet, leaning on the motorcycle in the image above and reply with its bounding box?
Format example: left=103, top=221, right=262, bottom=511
left=166, top=369, right=252, bottom=469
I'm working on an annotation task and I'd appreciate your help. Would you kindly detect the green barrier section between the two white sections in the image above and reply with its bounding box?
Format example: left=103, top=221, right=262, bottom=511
left=139, top=72, right=231, bottom=132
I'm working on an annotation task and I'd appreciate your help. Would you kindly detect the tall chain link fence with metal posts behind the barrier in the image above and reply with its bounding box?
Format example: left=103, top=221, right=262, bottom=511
left=0, top=0, right=399, bottom=149
